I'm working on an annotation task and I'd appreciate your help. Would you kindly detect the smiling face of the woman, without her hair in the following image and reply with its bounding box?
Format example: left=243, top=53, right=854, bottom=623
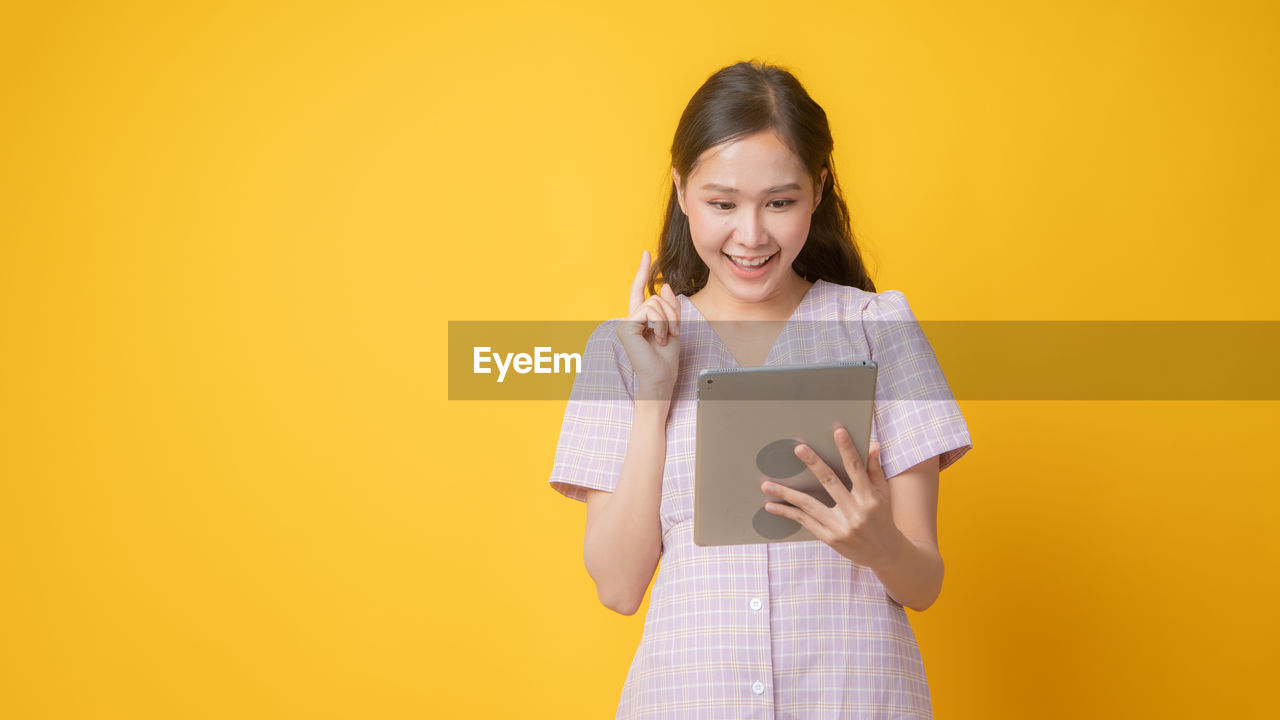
left=671, top=131, right=827, bottom=302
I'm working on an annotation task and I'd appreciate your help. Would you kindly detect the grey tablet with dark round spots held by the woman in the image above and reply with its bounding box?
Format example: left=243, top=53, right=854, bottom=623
left=694, top=360, right=877, bottom=546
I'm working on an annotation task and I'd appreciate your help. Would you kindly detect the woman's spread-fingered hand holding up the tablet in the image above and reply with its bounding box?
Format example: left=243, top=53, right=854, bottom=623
left=760, top=427, right=905, bottom=568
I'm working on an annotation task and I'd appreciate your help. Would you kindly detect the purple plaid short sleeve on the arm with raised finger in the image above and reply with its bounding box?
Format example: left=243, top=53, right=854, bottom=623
left=550, top=320, right=635, bottom=501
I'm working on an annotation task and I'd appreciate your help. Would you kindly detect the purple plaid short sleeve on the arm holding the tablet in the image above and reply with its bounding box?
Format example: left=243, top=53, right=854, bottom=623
left=863, top=290, right=973, bottom=478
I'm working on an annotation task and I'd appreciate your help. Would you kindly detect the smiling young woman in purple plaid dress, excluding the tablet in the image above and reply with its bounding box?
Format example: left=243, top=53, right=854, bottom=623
left=550, top=63, right=972, bottom=719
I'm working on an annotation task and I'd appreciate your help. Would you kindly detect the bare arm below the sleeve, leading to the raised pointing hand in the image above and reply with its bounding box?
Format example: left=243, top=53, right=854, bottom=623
left=582, top=400, right=671, bottom=615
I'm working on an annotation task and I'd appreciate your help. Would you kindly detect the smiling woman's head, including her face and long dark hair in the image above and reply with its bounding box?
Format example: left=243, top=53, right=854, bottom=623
left=648, top=63, right=876, bottom=316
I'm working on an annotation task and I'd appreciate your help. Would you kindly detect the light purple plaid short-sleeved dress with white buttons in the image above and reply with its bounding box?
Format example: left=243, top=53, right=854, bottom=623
left=550, top=281, right=972, bottom=720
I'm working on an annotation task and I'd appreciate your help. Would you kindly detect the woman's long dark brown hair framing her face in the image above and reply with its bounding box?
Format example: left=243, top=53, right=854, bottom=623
left=649, top=61, right=876, bottom=295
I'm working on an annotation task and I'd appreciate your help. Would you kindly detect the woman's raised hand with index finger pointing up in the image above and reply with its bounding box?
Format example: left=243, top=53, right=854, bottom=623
left=618, top=250, right=680, bottom=401
